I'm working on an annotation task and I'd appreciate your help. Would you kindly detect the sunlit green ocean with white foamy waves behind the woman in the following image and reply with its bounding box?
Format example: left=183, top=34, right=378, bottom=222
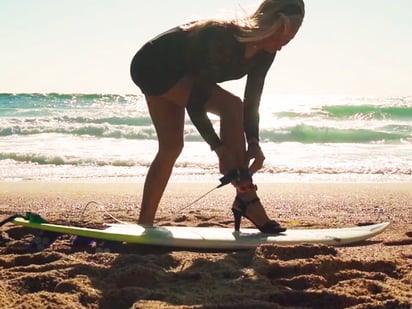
left=0, top=93, right=412, bottom=184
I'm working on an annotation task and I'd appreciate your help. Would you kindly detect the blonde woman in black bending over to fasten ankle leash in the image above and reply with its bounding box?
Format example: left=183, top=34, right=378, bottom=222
left=131, top=0, right=304, bottom=233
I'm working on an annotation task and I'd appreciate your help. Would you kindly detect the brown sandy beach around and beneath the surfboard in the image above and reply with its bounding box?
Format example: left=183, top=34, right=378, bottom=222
left=0, top=182, right=412, bottom=309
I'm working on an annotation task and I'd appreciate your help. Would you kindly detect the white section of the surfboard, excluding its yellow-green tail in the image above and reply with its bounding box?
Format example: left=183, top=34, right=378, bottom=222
left=105, top=222, right=389, bottom=249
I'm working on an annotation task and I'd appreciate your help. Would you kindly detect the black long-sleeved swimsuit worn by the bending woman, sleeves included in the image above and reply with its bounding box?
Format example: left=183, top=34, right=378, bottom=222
left=131, top=23, right=275, bottom=149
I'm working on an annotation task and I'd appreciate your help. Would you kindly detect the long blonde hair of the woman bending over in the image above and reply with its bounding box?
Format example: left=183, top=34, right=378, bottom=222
left=181, top=0, right=305, bottom=43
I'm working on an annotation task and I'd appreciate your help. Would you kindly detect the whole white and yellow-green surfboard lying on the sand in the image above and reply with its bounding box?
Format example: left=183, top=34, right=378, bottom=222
left=12, top=218, right=389, bottom=249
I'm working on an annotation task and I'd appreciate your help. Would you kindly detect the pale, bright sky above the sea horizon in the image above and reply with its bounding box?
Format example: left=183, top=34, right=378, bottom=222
left=0, top=0, right=412, bottom=96
